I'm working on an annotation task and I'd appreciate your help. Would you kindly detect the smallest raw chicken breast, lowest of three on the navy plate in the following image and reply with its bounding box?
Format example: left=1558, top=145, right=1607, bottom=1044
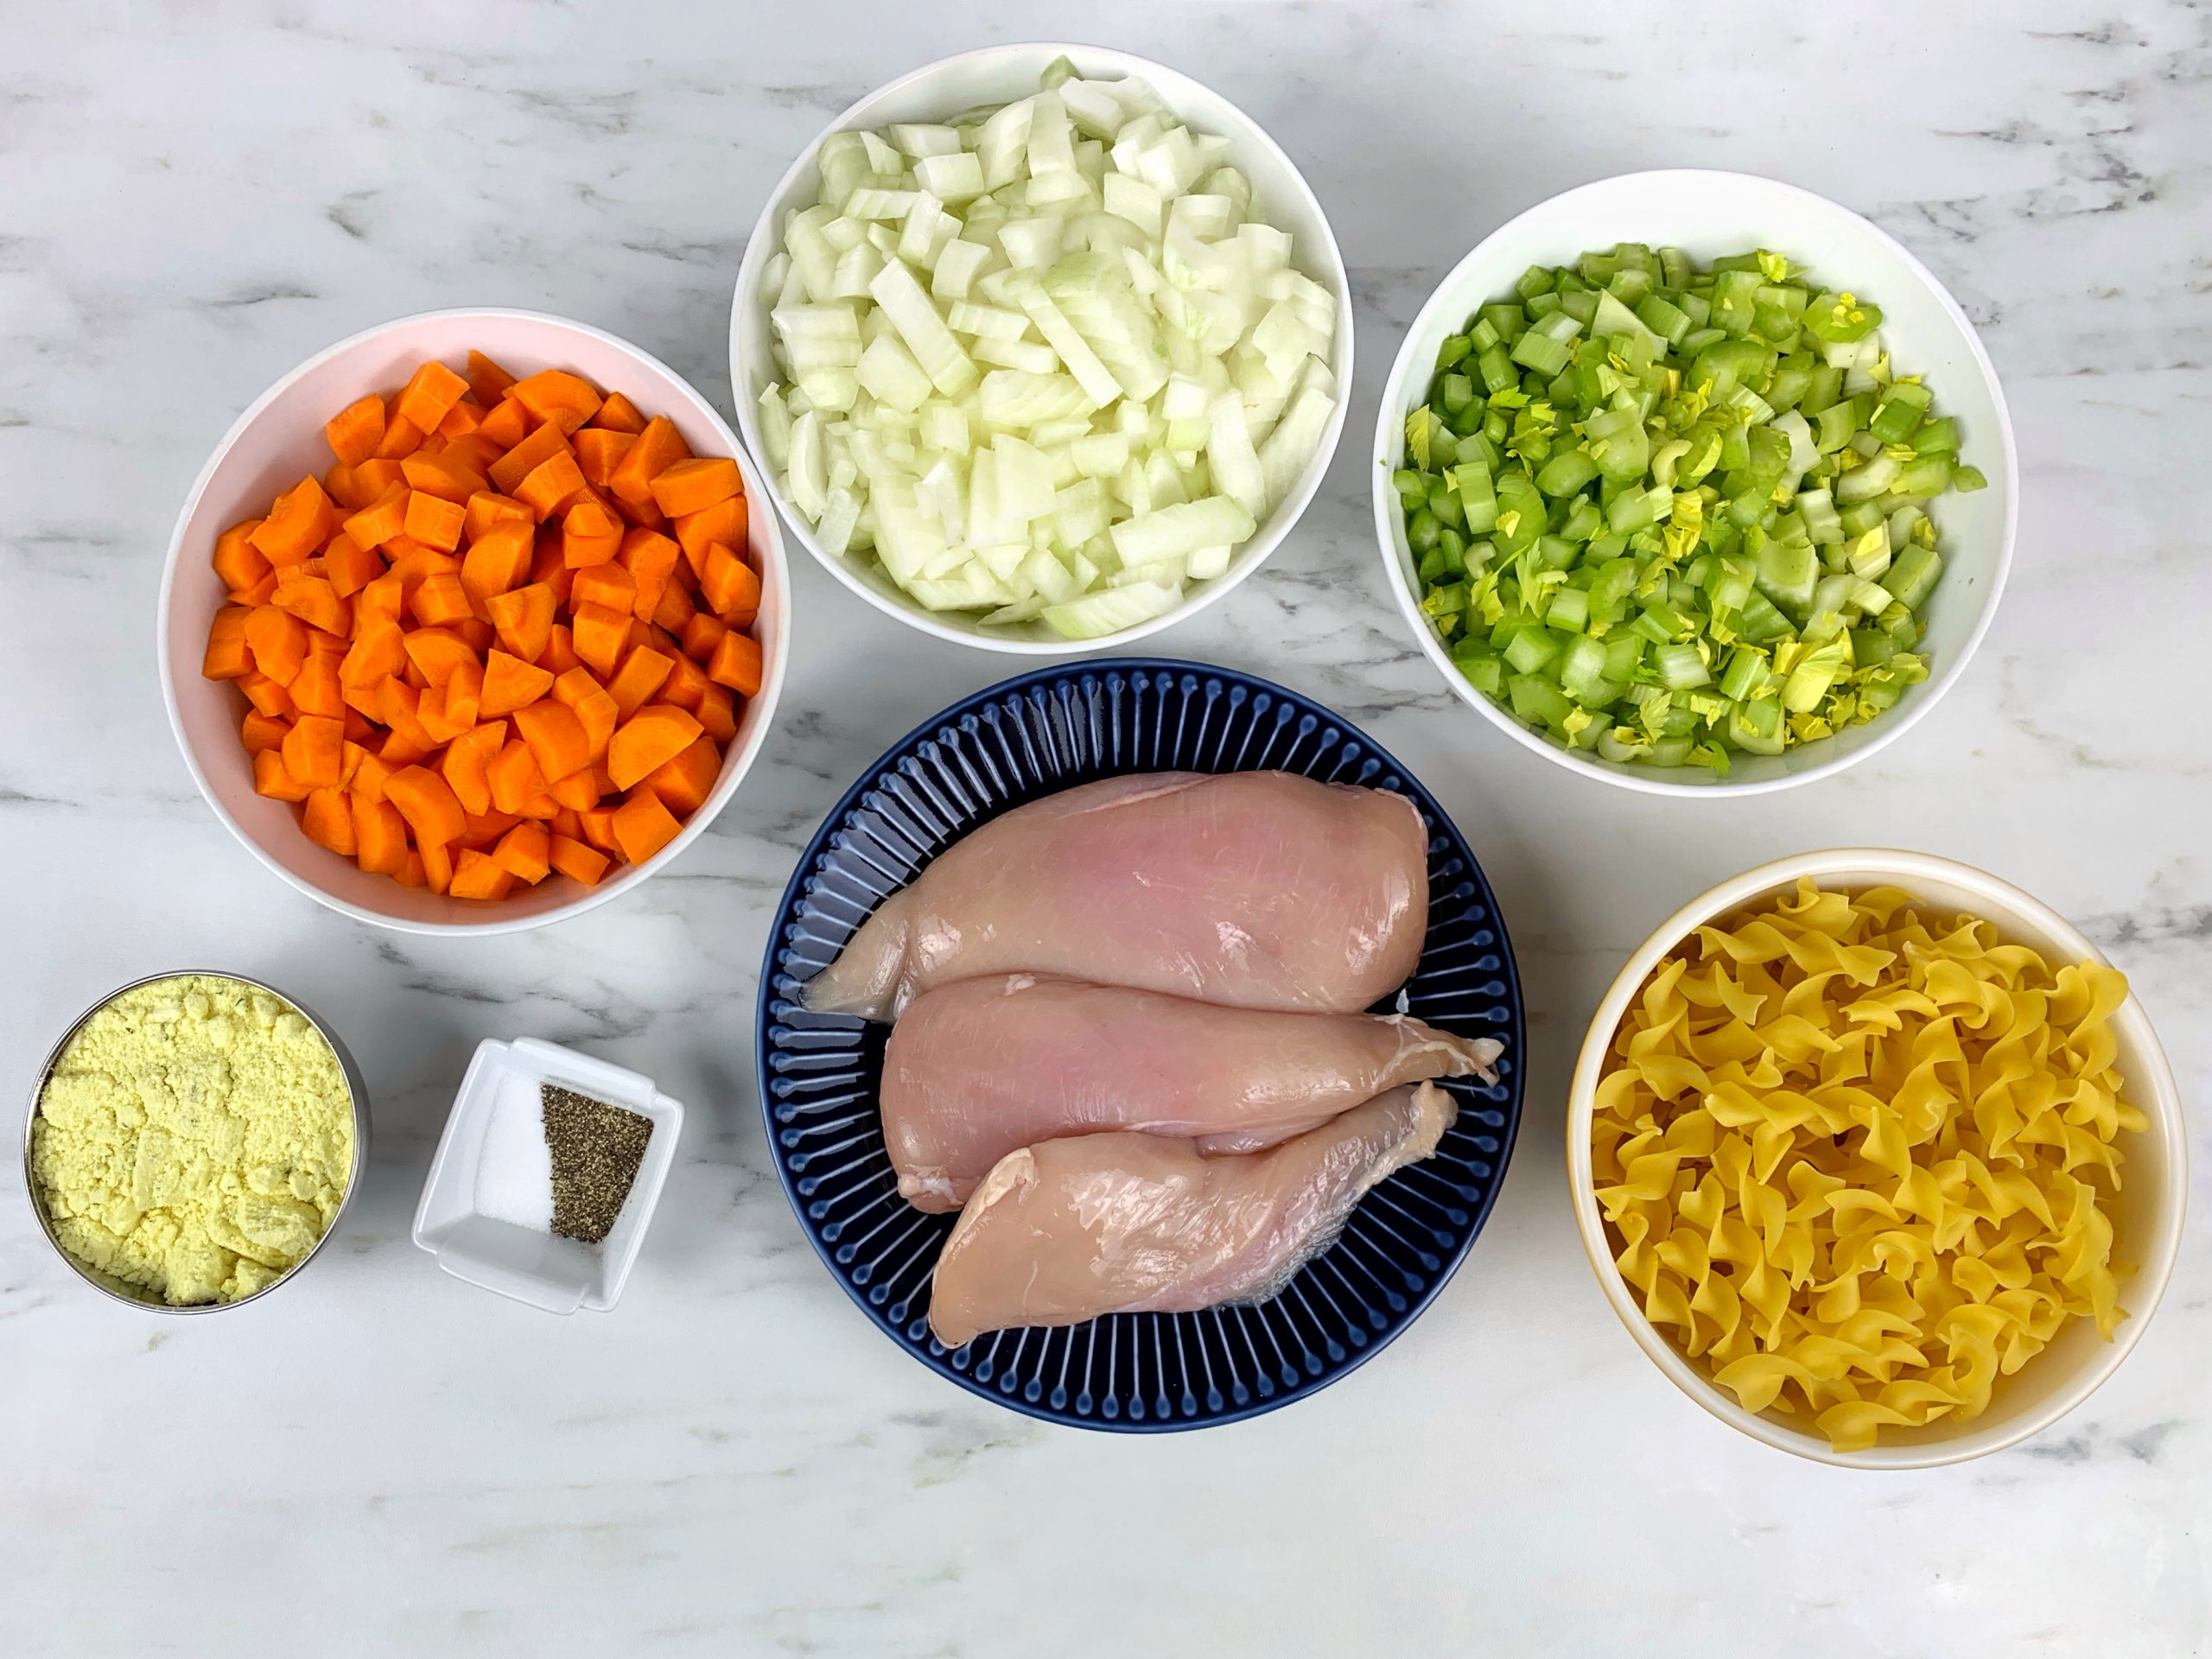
left=929, top=1084, right=1458, bottom=1347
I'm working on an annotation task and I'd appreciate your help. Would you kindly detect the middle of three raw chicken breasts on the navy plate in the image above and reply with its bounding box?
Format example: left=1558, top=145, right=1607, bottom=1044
left=882, top=973, right=1497, bottom=1210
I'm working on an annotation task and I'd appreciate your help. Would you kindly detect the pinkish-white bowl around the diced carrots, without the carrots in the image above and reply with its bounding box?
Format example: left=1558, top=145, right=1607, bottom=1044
left=157, top=309, right=790, bottom=933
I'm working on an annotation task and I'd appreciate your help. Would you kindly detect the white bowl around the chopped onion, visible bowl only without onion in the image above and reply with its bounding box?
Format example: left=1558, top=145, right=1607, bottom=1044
left=730, top=42, right=1351, bottom=657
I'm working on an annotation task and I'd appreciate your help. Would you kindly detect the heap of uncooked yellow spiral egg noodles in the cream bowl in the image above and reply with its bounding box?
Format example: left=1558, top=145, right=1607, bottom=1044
left=1591, top=880, right=2145, bottom=1451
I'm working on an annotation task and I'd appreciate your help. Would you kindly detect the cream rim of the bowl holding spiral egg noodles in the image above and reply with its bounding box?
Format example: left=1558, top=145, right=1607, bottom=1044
left=1566, top=847, right=2188, bottom=1469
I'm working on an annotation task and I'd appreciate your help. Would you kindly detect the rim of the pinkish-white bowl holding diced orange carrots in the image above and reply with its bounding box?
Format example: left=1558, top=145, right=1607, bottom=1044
left=155, top=305, right=791, bottom=942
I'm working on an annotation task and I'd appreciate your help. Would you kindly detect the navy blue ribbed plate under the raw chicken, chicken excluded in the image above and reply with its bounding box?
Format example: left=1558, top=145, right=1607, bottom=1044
left=757, top=659, right=1522, bottom=1431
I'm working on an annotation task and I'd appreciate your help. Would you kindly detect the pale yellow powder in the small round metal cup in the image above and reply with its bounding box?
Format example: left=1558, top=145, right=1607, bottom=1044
left=31, top=976, right=354, bottom=1307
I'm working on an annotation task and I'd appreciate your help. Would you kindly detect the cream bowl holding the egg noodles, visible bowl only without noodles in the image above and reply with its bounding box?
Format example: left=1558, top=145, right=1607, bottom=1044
left=1566, top=847, right=2188, bottom=1469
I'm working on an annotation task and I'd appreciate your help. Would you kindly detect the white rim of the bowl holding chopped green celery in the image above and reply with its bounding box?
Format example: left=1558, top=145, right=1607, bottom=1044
left=1370, top=168, right=2019, bottom=801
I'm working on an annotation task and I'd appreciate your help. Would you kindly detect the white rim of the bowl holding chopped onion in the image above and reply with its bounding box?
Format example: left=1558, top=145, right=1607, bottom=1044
left=730, top=40, right=1358, bottom=661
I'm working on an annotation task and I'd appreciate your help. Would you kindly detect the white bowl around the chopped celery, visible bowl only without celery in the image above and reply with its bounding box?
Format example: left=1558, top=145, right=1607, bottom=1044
left=1374, top=168, right=2019, bottom=794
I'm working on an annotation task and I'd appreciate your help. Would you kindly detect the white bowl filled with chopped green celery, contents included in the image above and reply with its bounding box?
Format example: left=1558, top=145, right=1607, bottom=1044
left=1374, top=170, right=2018, bottom=794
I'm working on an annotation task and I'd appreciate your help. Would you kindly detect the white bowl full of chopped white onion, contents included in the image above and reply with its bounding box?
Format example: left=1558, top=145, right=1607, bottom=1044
left=730, top=44, right=1351, bottom=657
